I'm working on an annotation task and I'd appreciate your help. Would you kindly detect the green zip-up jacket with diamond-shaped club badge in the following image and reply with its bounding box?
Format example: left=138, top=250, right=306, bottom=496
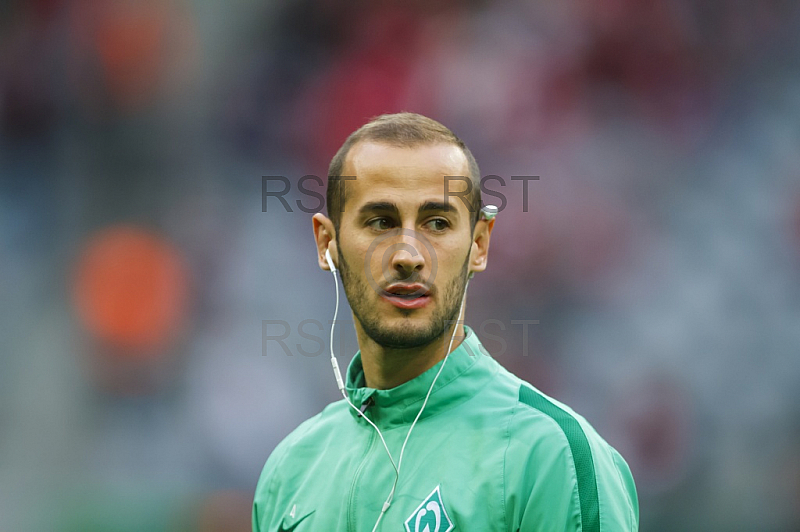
left=253, top=328, right=639, bottom=532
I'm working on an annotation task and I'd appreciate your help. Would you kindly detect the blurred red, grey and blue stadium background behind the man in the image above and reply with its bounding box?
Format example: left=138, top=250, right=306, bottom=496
left=0, top=0, right=800, bottom=532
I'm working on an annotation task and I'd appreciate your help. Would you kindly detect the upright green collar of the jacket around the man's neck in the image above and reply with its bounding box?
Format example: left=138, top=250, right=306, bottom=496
left=346, top=326, right=499, bottom=429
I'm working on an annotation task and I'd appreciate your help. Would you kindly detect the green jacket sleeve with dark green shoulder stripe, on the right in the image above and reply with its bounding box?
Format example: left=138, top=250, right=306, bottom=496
left=505, top=388, right=639, bottom=532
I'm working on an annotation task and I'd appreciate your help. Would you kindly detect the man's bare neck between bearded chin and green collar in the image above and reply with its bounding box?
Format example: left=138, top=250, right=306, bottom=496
left=355, top=313, right=466, bottom=390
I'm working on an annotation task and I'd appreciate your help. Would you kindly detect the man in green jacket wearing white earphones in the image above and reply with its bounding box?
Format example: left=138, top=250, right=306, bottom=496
left=253, top=113, right=639, bottom=532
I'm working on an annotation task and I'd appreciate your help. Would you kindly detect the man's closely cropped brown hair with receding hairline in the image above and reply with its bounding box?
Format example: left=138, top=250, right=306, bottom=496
left=326, top=113, right=481, bottom=233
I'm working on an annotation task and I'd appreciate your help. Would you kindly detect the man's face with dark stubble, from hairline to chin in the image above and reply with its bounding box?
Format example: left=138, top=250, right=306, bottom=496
left=337, top=142, right=472, bottom=348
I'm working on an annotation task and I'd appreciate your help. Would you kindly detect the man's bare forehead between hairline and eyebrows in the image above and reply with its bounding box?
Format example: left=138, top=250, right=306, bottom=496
left=342, top=141, right=469, bottom=204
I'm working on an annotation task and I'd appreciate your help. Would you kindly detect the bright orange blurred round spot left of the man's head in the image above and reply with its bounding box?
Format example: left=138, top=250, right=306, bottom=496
left=73, top=226, right=189, bottom=357
